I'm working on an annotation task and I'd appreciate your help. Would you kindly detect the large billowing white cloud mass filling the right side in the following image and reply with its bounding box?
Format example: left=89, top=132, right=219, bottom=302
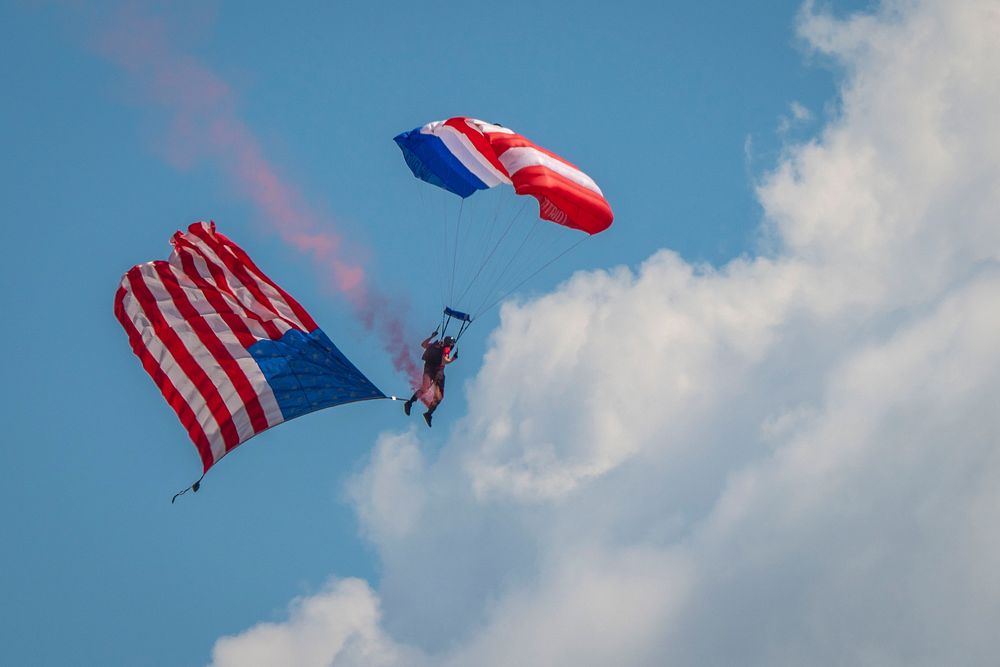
left=216, top=0, right=1000, bottom=666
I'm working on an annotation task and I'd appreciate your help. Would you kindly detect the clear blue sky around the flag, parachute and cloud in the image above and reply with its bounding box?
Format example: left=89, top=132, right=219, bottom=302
left=13, top=0, right=1000, bottom=665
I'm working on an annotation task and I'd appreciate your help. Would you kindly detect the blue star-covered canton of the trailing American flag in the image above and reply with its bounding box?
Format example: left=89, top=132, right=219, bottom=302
left=249, top=329, right=386, bottom=421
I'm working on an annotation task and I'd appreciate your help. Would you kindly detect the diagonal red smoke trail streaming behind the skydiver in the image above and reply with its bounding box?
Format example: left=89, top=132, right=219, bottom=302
left=97, top=6, right=420, bottom=383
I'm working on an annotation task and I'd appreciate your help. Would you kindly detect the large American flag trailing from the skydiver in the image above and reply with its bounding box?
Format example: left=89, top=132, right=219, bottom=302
left=115, top=222, right=386, bottom=472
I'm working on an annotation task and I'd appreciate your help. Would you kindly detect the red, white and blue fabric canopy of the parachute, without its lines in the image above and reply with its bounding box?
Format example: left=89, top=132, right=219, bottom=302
left=394, top=116, right=614, bottom=234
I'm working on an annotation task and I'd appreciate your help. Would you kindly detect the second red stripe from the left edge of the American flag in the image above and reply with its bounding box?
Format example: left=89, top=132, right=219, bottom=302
left=125, top=262, right=240, bottom=451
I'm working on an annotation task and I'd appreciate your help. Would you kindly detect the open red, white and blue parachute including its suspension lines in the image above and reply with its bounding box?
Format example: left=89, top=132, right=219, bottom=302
left=394, top=116, right=614, bottom=337
